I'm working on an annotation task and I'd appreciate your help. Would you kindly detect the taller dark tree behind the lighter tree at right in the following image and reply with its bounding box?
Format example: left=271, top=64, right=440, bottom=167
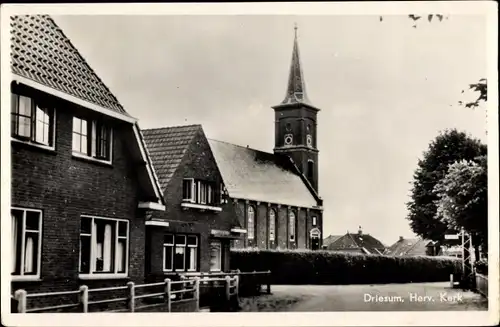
left=407, top=129, right=486, bottom=242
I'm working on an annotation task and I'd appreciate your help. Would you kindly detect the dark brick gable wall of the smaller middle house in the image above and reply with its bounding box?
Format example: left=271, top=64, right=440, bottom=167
left=148, top=130, right=238, bottom=278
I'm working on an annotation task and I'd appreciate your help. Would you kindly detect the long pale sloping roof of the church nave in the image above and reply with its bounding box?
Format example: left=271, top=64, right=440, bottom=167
left=209, top=140, right=318, bottom=208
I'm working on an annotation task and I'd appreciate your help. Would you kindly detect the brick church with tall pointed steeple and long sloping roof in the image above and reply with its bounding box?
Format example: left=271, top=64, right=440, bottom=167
left=210, top=25, right=323, bottom=249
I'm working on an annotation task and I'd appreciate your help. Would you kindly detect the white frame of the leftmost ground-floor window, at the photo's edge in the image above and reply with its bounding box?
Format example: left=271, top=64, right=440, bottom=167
left=10, top=206, right=43, bottom=281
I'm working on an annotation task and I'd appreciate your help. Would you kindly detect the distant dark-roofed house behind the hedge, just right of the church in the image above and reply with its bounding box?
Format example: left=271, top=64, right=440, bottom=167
left=323, top=228, right=385, bottom=255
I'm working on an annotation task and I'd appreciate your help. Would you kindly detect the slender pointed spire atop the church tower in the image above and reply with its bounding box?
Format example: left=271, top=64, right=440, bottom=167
left=281, top=23, right=309, bottom=105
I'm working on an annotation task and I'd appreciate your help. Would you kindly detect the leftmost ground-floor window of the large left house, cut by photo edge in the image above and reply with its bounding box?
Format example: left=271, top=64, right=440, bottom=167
left=11, top=208, right=42, bottom=277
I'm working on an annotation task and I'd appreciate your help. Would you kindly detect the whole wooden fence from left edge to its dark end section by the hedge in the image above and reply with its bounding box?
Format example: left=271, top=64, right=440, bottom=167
left=12, top=271, right=271, bottom=313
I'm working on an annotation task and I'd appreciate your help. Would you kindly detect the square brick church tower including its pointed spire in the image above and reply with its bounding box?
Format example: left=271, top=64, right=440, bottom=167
left=272, top=26, right=319, bottom=192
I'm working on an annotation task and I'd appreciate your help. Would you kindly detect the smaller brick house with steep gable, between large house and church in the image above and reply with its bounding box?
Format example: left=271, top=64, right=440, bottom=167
left=144, top=125, right=244, bottom=280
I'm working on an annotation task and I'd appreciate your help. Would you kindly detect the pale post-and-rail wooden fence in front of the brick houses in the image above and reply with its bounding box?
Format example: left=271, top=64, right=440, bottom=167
left=13, top=276, right=238, bottom=313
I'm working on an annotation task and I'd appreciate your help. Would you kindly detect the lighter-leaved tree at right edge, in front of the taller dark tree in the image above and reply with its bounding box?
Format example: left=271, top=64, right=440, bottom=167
left=434, top=156, right=488, bottom=258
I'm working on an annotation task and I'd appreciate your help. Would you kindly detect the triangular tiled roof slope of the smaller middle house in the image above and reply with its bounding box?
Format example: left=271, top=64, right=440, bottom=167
left=142, top=125, right=201, bottom=190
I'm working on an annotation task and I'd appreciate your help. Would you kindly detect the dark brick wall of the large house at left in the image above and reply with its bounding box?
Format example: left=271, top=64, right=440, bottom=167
left=11, top=86, right=145, bottom=302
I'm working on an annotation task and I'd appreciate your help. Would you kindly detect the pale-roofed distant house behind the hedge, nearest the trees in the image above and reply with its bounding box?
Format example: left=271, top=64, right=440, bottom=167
left=384, top=236, right=441, bottom=256
